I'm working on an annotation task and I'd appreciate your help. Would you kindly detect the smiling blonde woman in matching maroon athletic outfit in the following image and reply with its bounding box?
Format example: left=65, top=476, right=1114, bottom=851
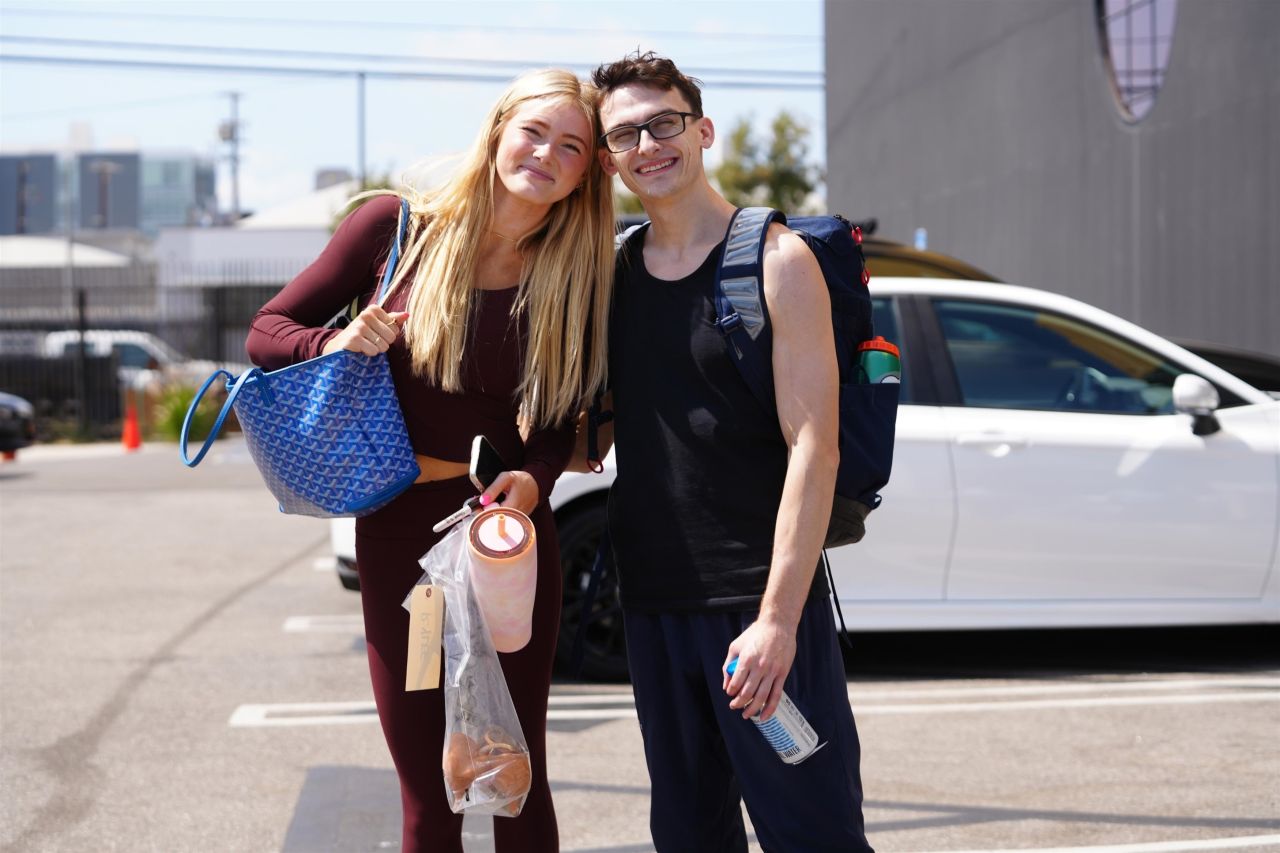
left=248, top=70, right=613, bottom=853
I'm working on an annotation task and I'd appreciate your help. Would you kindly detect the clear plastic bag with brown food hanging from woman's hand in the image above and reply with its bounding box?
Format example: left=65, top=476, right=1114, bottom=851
left=406, top=519, right=532, bottom=817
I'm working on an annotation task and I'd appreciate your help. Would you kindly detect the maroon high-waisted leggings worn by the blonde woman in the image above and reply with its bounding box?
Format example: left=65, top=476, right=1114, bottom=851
left=356, top=478, right=561, bottom=853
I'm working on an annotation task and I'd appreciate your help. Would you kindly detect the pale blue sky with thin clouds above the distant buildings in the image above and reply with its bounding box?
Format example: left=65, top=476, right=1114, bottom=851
left=0, top=0, right=824, bottom=210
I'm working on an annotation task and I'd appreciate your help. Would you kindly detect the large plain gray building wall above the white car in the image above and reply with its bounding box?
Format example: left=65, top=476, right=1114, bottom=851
left=826, top=0, right=1280, bottom=353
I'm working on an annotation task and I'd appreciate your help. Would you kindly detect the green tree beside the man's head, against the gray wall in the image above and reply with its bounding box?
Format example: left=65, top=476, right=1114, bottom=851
left=714, top=110, right=822, bottom=213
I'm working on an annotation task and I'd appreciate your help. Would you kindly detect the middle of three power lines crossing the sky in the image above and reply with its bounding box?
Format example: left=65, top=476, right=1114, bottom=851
left=0, top=35, right=823, bottom=78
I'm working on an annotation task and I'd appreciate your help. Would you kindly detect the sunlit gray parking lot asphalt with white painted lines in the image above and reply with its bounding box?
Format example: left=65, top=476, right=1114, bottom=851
left=0, top=441, right=1280, bottom=853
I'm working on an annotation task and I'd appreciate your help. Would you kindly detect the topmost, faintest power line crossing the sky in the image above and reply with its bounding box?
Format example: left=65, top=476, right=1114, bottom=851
left=4, top=8, right=822, bottom=42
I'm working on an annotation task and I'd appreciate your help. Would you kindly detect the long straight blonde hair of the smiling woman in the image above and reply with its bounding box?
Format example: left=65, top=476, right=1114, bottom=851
left=376, top=69, right=613, bottom=428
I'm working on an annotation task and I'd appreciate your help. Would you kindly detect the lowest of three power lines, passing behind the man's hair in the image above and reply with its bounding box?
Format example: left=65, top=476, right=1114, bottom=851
left=0, top=54, right=823, bottom=91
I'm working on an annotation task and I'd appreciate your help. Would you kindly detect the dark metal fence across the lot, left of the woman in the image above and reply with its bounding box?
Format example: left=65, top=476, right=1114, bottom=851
left=0, top=264, right=298, bottom=441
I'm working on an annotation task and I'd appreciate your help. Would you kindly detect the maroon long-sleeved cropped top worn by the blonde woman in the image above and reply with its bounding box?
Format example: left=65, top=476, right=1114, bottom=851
left=246, top=196, right=575, bottom=500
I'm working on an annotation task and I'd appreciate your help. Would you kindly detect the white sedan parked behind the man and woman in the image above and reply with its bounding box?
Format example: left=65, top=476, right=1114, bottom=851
left=335, top=278, right=1280, bottom=678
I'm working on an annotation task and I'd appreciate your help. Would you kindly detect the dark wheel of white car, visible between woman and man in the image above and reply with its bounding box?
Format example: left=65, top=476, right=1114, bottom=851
left=556, top=502, right=627, bottom=681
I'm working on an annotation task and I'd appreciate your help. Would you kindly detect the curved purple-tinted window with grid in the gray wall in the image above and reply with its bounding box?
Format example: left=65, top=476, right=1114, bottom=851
left=1094, top=0, right=1178, bottom=122
